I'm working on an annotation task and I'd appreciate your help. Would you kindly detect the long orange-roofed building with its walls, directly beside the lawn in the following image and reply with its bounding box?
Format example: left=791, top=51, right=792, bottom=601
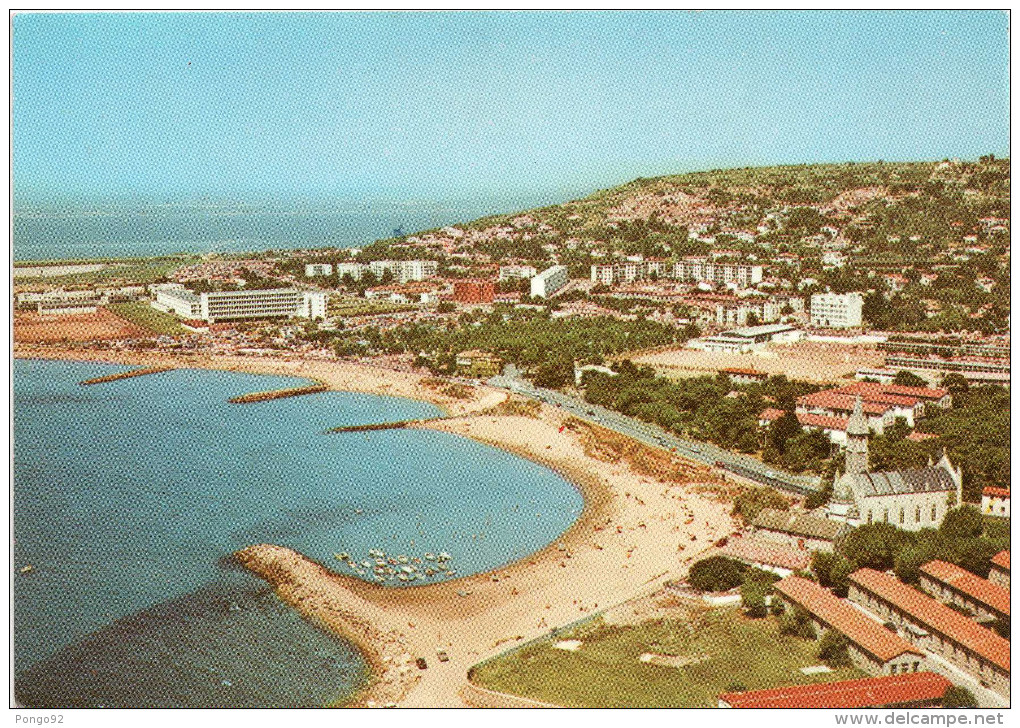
left=774, top=576, right=927, bottom=675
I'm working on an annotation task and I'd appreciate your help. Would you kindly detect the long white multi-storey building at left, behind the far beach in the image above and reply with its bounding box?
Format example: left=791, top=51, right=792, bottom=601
left=151, top=283, right=326, bottom=323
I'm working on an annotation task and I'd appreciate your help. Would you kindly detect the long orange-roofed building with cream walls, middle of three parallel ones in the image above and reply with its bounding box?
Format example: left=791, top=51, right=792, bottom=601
left=850, top=569, right=1010, bottom=696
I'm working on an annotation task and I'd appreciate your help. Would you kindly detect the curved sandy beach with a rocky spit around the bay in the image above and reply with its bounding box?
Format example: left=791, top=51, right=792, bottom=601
left=15, top=350, right=736, bottom=707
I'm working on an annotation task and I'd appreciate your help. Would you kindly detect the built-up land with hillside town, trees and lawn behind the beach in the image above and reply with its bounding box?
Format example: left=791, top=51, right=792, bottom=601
left=13, top=155, right=1011, bottom=708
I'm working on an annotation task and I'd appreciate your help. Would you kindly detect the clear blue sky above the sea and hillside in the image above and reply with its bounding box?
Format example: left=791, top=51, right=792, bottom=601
left=13, top=11, right=1009, bottom=201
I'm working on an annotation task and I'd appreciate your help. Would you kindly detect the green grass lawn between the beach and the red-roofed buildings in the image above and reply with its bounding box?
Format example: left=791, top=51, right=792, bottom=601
left=474, top=609, right=866, bottom=708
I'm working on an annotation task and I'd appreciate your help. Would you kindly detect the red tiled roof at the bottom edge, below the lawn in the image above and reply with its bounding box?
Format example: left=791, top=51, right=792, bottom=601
left=719, top=672, right=953, bottom=709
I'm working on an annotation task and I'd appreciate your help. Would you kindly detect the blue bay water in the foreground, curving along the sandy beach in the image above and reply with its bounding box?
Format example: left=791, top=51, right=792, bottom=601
left=13, top=360, right=582, bottom=706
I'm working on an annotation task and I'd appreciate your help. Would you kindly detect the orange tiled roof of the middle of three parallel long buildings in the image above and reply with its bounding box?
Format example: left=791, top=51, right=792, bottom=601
left=850, top=569, right=1010, bottom=672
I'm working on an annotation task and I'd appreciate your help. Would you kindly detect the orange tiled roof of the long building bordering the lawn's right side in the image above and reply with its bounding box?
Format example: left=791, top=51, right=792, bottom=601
left=775, top=576, right=926, bottom=663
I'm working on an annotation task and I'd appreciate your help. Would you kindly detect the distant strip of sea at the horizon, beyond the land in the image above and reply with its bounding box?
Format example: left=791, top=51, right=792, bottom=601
left=13, top=196, right=554, bottom=260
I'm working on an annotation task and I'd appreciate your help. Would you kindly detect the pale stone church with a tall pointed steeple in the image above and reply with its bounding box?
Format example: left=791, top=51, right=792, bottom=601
left=827, top=397, right=963, bottom=531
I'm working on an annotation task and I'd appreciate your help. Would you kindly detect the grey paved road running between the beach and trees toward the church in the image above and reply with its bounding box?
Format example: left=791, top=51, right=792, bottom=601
left=488, top=376, right=821, bottom=495
